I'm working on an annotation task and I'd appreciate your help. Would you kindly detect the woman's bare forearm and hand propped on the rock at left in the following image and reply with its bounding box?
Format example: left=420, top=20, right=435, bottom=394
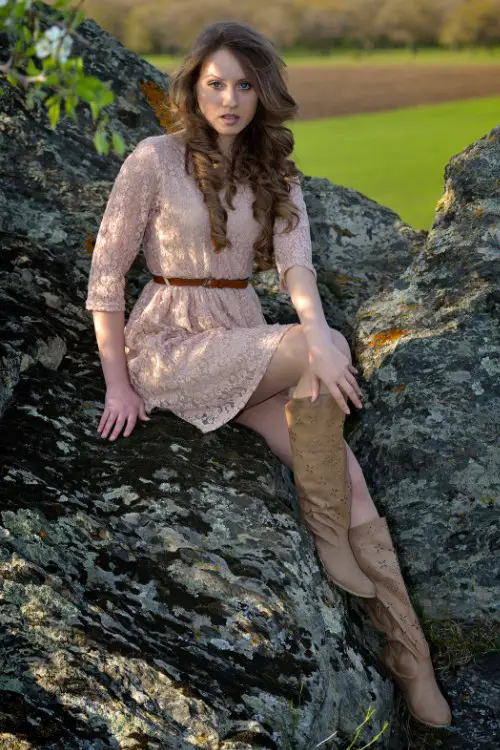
left=92, top=310, right=149, bottom=440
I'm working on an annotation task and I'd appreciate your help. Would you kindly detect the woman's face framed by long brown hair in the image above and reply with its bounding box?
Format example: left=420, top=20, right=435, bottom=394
left=196, top=49, right=258, bottom=154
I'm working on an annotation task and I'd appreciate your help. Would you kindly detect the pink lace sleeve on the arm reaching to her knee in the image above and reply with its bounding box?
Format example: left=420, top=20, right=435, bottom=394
left=273, top=182, right=318, bottom=292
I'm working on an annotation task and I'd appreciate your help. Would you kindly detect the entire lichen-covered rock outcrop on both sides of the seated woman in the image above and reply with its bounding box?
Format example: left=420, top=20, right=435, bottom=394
left=0, top=1, right=500, bottom=750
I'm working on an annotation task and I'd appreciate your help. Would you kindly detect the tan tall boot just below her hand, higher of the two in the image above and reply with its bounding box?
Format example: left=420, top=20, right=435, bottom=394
left=285, top=393, right=375, bottom=597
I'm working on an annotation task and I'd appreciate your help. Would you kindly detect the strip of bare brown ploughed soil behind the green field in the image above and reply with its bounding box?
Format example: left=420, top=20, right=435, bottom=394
left=287, top=65, right=500, bottom=122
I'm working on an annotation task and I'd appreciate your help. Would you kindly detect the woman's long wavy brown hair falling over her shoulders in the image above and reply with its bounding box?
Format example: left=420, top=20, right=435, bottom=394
left=168, top=21, right=301, bottom=270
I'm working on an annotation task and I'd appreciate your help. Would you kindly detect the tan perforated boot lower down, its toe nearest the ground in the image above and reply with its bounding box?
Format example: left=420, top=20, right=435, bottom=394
left=349, top=517, right=451, bottom=727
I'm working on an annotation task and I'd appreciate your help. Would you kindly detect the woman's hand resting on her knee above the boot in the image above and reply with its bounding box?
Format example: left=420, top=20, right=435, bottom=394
left=309, top=339, right=363, bottom=414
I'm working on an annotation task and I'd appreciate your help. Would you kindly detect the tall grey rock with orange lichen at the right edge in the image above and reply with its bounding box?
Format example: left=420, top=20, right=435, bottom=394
left=350, top=130, right=500, bottom=623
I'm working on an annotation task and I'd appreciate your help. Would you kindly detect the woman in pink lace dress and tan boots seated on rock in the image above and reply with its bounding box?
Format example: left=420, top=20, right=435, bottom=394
left=86, top=22, right=451, bottom=726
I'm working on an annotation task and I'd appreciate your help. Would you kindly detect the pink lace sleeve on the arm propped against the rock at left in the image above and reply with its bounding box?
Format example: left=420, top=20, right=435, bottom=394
left=85, top=138, right=159, bottom=312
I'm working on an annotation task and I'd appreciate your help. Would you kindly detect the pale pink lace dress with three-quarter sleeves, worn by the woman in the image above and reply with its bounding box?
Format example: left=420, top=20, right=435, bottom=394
left=85, top=134, right=316, bottom=433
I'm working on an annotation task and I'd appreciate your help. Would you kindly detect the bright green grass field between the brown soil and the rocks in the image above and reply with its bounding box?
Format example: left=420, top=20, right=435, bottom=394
left=289, top=96, right=500, bottom=229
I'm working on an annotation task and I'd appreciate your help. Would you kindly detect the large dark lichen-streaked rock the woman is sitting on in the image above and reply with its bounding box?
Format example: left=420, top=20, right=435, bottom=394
left=0, top=5, right=397, bottom=750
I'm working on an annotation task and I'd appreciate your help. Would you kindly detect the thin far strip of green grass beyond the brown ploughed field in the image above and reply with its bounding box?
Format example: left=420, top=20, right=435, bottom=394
left=142, top=47, right=500, bottom=71
